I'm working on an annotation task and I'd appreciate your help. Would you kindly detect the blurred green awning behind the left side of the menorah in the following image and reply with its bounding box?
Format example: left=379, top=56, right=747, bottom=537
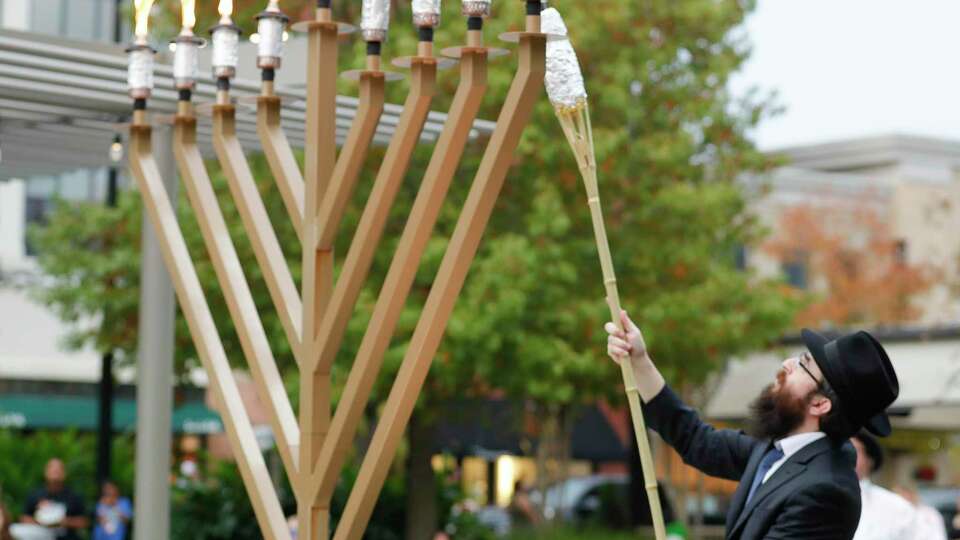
left=0, top=394, right=223, bottom=434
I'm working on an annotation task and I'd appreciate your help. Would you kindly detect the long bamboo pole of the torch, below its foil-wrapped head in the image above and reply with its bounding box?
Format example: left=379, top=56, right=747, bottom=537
left=557, top=101, right=666, bottom=540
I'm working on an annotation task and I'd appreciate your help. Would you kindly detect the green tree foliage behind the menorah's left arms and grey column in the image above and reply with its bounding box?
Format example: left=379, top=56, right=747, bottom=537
left=29, top=152, right=300, bottom=380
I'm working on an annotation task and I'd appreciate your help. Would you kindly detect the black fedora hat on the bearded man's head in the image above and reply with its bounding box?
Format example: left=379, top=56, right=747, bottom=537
left=800, top=328, right=900, bottom=437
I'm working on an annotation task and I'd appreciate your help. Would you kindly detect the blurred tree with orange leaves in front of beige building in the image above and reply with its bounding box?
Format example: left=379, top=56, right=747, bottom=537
left=764, top=205, right=939, bottom=326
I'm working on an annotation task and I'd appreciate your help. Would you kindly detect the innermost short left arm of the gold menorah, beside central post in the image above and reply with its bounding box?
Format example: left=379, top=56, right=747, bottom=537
left=257, top=96, right=303, bottom=241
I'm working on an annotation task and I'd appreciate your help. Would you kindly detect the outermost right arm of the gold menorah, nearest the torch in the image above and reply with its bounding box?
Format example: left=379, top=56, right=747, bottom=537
left=334, top=33, right=546, bottom=540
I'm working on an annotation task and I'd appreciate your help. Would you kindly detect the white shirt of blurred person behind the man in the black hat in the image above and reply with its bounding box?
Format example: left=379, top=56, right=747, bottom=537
left=853, top=480, right=917, bottom=540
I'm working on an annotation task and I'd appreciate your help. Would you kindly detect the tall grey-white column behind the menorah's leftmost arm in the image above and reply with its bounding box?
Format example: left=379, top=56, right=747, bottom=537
left=133, top=127, right=177, bottom=540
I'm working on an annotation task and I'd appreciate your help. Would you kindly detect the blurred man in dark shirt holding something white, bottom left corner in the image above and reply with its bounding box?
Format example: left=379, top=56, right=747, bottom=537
left=20, top=458, right=90, bottom=540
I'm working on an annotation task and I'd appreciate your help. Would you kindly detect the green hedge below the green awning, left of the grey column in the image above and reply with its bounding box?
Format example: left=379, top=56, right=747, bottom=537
left=0, top=430, right=134, bottom=519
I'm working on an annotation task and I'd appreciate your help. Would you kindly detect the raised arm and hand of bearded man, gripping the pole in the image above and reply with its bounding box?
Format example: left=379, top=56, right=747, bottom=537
left=605, top=312, right=758, bottom=480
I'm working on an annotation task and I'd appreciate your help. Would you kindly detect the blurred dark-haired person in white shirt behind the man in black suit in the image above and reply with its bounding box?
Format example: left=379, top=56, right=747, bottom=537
left=850, top=431, right=933, bottom=540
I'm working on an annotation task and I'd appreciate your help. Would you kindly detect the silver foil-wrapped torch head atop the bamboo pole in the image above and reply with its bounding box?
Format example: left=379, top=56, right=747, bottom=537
left=540, top=8, right=587, bottom=111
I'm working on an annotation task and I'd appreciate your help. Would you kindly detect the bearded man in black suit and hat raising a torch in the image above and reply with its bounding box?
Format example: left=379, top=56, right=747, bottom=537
left=605, top=312, right=899, bottom=540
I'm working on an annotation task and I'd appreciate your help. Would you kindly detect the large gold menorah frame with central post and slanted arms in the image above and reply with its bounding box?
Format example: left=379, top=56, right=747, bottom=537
left=130, top=0, right=546, bottom=540
